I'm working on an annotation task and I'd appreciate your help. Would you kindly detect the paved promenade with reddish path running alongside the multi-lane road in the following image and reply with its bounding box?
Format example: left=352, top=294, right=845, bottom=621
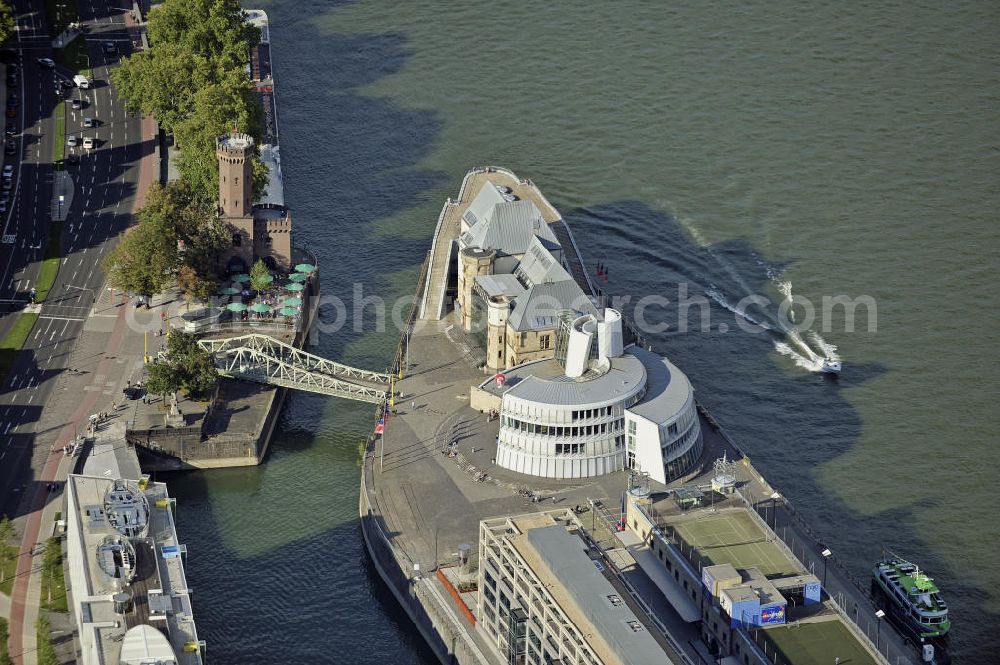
left=9, top=111, right=158, bottom=665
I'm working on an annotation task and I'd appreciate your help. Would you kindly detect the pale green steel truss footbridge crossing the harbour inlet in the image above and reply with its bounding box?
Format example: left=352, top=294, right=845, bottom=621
left=198, top=335, right=391, bottom=404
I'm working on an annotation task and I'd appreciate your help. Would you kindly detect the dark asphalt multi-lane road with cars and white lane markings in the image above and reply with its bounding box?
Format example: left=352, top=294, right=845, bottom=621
left=0, top=0, right=143, bottom=528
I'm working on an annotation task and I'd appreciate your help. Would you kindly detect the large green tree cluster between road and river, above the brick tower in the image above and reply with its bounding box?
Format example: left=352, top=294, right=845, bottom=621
left=111, top=0, right=267, bottom=202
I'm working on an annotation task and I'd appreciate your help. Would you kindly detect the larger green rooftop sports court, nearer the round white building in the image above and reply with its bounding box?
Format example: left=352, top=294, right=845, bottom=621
left=672, top=510, right=800, bottom=577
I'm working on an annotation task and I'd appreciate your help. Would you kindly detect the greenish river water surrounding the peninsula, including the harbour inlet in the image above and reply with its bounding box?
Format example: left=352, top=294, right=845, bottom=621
left=160, top=0, right=1000, bottom=663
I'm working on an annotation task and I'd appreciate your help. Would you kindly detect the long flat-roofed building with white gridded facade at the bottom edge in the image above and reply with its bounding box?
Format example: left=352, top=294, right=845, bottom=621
left=477, top=510, right=671, bottom=665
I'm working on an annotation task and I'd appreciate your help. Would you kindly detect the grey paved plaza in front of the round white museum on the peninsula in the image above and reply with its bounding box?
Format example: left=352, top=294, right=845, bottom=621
left=361, top=320, right=721, bottom=663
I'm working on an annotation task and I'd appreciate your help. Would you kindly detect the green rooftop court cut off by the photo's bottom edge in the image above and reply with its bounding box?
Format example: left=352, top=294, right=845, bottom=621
left=764, top=619, right=875, bottom=665
